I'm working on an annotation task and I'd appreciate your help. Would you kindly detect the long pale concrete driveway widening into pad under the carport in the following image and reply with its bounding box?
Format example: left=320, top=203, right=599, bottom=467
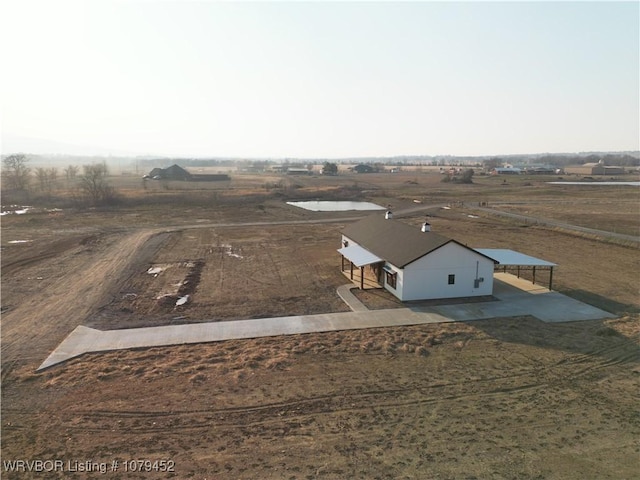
left=38, top=274, right=614, bottom=370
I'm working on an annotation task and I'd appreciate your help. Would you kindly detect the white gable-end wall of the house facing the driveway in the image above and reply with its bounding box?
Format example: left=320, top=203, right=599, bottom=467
left=400, top=242, right=494, bottom=301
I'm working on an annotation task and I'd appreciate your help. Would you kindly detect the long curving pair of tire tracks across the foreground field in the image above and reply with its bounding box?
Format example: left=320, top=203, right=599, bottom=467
left=40, top=343, right=638, bottom=435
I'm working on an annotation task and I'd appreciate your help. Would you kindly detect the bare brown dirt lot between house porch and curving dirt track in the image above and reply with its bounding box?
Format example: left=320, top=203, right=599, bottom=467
left=87, top=225, right=349, bottom=330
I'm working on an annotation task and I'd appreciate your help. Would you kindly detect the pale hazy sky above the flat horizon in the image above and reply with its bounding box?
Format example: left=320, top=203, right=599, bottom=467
left=0, top=0, right=640, bottom=158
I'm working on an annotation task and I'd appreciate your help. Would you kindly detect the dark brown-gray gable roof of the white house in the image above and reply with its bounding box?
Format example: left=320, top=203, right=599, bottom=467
left=342, top=213, right=482, bottom=268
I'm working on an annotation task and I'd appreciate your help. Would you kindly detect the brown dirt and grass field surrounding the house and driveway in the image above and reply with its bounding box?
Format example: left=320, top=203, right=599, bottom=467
left=1, top=172, right=640, bottom=479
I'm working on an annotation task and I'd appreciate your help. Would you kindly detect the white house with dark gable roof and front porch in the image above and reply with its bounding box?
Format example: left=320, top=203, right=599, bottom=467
left=338, top=214, right=498, bottom=301
